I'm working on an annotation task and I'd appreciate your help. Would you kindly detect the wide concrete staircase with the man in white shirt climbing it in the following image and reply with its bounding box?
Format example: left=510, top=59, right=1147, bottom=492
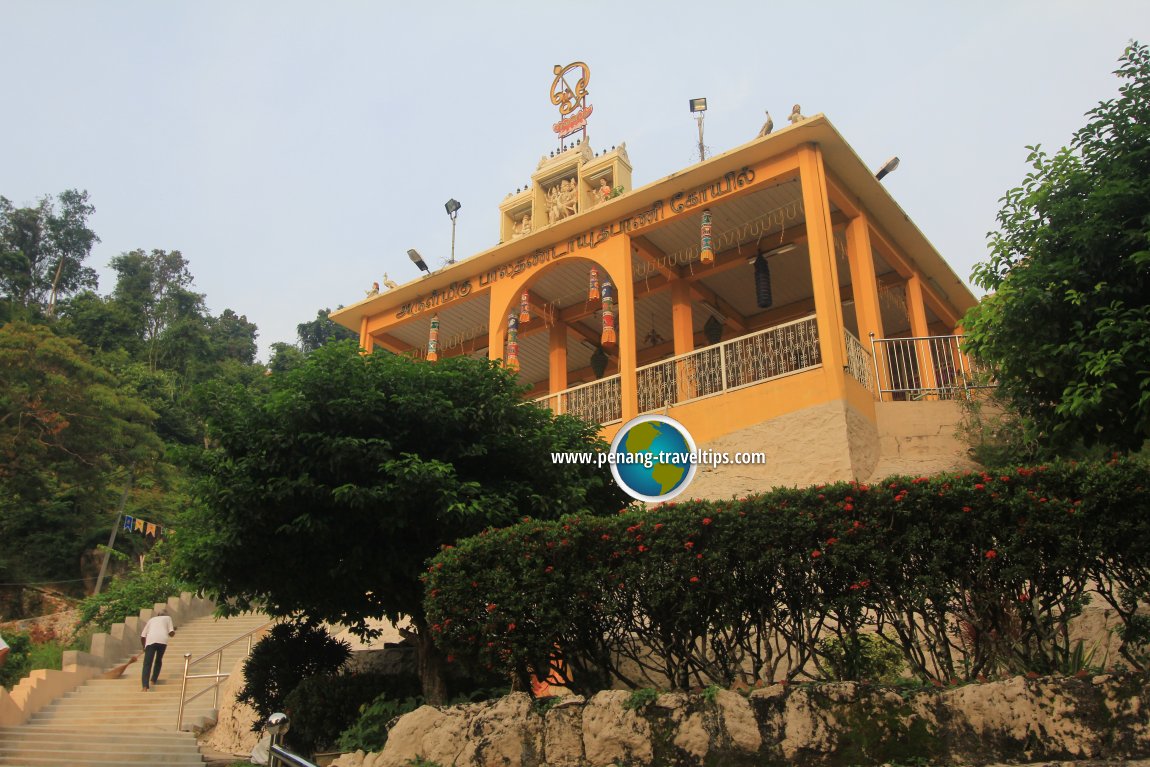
left=0, top=614, right=269, bottom=767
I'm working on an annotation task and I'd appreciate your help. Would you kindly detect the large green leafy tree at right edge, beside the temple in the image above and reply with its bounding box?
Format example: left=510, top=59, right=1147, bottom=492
left=964, top=43, right=1150, bottom=450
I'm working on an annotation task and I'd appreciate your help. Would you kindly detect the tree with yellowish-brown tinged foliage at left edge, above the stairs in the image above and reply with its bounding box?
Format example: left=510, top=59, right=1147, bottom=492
left=0, top=322, right=161, bottom=577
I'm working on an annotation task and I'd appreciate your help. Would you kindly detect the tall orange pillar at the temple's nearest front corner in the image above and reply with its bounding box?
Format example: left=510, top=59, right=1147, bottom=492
left=798, top=144, right=846, bottom=393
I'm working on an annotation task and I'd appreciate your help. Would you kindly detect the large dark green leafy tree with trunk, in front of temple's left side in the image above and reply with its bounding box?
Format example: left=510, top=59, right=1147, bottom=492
left=177, top=342, right=624, bottom=700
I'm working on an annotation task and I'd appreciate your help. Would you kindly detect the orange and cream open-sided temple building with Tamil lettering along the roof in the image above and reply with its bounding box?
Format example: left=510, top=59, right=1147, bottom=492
left=331, top=115, right=975, bottom=497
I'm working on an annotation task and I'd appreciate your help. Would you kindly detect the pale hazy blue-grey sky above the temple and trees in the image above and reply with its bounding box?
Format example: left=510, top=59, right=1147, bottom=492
left=0, top=0, right=1150, bottom=356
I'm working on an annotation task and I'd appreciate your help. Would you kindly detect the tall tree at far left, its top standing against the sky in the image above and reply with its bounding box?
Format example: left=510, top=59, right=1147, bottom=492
left=0, top=190, right=100, bottom=321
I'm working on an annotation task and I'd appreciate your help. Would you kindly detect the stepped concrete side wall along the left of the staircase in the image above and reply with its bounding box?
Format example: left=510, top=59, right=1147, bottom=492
left=0, top=592, right=215, bottom=726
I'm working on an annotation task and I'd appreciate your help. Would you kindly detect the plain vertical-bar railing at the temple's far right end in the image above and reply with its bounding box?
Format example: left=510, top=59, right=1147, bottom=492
left=871, top=336, right=996, bottom=401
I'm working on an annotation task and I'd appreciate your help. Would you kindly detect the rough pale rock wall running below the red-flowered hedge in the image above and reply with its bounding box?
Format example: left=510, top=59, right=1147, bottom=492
left=334, top=674, right=1150, bottom=767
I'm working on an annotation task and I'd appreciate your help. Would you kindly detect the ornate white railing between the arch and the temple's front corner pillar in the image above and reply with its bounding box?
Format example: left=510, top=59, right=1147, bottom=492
left=636, top=315, right=822, bottom=413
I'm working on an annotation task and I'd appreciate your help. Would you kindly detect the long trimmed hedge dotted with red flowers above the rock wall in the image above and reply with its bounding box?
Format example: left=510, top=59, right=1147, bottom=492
left=424, top=460, right=1150, bottom=691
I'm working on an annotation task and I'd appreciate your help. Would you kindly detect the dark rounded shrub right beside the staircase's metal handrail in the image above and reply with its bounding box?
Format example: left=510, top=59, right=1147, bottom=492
left=236, top=619, right=351, bottom=731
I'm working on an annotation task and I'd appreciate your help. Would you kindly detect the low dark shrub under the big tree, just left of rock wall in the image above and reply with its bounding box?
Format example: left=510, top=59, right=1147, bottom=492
left=284, top=674, right=420, bottom=754
